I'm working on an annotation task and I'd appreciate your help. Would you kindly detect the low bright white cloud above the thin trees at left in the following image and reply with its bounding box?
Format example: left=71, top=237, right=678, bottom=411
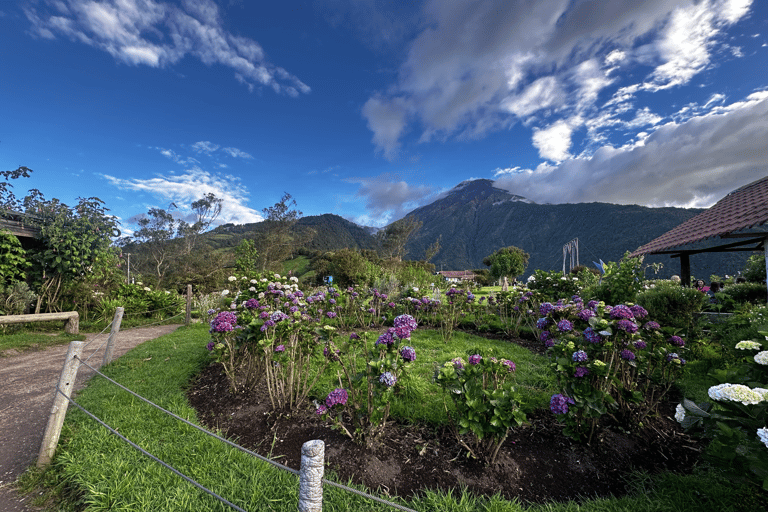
left=102, top=168, right=264, bottom=224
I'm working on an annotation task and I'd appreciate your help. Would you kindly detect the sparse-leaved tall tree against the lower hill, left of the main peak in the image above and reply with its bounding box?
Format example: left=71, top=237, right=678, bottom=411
left=254, top=192, right=302, bottom=271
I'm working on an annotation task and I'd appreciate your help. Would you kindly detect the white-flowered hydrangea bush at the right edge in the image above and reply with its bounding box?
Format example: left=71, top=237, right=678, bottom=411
left=675, top=331, right=768, bottom=490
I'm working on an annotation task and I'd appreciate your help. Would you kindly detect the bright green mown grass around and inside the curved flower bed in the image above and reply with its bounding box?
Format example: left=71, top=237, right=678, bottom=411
left=23, top=324, right=762, bottom=512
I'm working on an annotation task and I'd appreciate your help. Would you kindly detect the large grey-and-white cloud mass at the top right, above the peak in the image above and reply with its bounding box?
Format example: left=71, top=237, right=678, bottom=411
left=362, top=0, right=751, bottom=159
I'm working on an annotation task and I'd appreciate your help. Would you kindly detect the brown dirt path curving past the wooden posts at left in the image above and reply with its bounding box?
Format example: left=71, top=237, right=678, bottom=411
left=0, top=325, right=179, bottom=512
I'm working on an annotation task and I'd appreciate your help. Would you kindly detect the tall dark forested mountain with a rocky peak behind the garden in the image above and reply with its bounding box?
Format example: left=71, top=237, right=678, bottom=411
left=406, top=179, right=749, bottom=281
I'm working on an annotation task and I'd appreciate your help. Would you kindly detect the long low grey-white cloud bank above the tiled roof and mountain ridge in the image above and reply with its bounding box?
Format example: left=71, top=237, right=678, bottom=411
left=495, top=95, right=768, bottom=207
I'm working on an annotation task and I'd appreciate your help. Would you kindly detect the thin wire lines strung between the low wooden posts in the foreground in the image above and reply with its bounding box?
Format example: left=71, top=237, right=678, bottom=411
left=67, top=356, right=417, bottom=512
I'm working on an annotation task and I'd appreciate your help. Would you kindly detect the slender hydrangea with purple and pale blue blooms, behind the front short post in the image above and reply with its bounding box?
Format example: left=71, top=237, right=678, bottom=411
left=317, top=315, right=417, bottom=447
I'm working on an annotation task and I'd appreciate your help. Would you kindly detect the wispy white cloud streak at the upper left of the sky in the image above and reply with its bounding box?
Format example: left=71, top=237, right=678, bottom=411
left=24, top=0, right=311, bottom=96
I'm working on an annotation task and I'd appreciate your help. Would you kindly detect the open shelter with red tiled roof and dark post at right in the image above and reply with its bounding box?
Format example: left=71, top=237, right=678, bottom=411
left=631, top=176, right=768, bottom=296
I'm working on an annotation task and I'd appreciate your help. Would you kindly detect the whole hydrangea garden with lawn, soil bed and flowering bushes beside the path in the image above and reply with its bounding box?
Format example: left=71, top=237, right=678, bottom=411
left=13, top=253, right=768, bottom=511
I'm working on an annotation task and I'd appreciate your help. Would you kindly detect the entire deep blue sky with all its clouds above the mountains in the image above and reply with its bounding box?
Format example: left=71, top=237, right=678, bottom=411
left=0, top=0, right=768, bottom=233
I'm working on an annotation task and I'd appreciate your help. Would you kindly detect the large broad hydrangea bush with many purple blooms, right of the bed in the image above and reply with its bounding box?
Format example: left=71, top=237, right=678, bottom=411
left=536, top=295, right=686, bottom=442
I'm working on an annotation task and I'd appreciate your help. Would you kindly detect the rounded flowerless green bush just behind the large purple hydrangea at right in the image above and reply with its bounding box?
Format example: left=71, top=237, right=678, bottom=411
left=635, top=281, right=709, bottom=338
